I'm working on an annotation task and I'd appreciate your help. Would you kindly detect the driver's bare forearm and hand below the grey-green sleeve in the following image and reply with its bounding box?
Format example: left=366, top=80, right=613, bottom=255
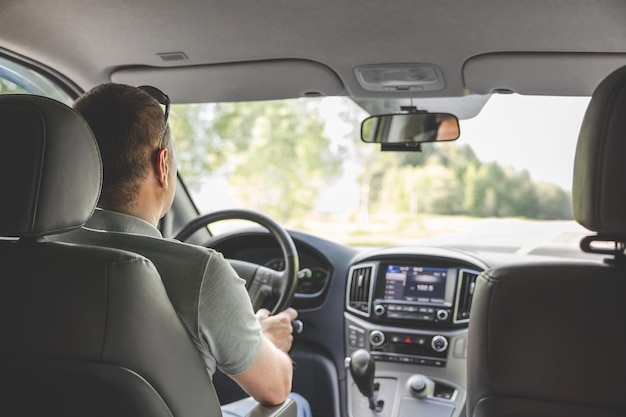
left=231, top=308, right=298, bottom=405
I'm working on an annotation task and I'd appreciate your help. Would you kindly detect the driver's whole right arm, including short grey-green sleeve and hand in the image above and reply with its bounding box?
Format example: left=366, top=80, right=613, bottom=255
left=198, top=250, right=298, bottom=405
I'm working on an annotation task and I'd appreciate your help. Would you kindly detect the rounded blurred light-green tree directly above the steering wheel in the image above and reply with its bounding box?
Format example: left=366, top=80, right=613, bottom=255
left=213, top=101, right=342, bottom=222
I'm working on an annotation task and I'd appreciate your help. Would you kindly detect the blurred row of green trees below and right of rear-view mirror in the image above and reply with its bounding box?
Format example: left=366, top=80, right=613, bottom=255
left=360, top=143, right=572, bottom=220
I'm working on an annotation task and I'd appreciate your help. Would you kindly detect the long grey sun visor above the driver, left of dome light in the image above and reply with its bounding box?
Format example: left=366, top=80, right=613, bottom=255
left=111, top=60, right=344, bottom=103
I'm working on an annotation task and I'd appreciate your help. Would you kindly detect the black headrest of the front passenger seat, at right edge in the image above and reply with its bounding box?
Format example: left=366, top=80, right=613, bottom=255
left=572, top=67, right=626, bottom=236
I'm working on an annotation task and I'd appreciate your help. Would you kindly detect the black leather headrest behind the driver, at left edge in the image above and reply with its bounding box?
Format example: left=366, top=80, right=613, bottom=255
left=0, top=95, right=102, bottom=237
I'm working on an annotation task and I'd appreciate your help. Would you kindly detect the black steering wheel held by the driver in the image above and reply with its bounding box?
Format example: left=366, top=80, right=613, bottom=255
left=174, top=209, right=299, bottom=314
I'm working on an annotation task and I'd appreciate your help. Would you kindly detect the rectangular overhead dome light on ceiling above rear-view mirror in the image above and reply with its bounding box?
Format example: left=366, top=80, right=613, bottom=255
left=354, top=64, right=445, bottom=92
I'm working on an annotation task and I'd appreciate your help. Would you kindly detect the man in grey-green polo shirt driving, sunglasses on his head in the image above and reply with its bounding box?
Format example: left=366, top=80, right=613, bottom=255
left=54, top=83, right=311, bottom=416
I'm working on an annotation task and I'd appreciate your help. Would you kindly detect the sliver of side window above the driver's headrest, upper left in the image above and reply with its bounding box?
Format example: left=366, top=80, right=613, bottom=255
left=0, top=56, right=73, bottom=106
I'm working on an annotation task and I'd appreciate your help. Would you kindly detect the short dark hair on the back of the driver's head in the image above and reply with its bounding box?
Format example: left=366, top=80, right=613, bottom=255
left=74, top=83, right=172, bottom=210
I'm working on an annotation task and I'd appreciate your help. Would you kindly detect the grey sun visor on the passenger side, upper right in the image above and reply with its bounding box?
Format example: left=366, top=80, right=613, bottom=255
left=463, top=52, right=626, bottom=96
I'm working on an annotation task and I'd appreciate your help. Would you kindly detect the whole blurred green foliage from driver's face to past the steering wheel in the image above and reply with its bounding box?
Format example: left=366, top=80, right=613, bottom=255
left=174, top=101, right=343, bottom=222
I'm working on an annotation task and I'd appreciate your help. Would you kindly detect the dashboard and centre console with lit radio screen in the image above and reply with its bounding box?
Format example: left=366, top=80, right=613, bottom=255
left=211, top=230, right=510, bottom=417
